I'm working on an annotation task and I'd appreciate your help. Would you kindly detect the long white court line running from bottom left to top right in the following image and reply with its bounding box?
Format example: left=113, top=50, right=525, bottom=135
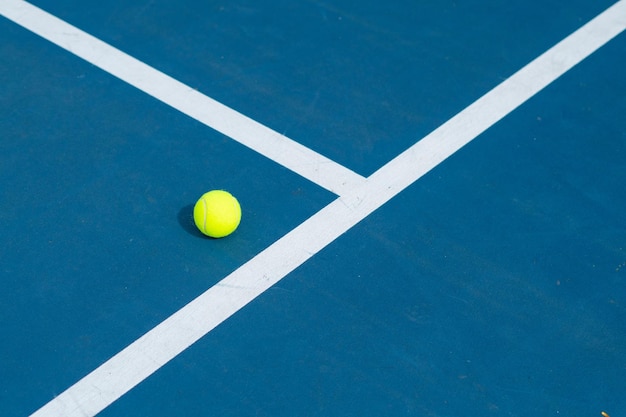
left=13, top=0, right=626, bottom=417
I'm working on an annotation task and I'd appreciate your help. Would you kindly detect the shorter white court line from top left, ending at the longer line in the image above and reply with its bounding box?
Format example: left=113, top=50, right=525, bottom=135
left=0, top=0, right=365, bottom=195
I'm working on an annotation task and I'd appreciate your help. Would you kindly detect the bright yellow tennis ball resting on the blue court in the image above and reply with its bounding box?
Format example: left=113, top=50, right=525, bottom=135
left=193, top=190, right=241, bottom=238
